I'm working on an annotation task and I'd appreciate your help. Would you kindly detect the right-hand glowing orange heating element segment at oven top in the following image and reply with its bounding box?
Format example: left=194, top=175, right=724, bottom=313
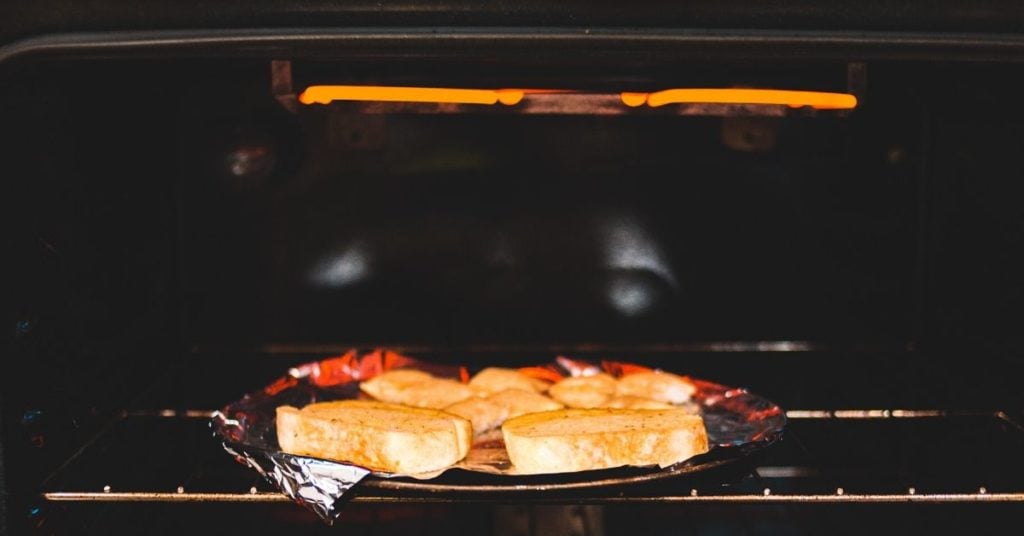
left=634, top=88, right=857, bottom=110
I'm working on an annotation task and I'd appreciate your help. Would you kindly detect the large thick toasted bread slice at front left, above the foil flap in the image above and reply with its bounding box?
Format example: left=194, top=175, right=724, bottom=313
left=276, top=400, right=473, bottom=475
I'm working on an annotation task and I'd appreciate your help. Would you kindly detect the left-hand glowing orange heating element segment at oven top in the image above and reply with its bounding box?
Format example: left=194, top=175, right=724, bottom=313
left=299, top=86, right=524, bottom=106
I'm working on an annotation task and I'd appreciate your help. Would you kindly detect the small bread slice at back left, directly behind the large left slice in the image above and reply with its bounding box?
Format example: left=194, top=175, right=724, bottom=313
left=359, top=369, right=473, bottom=409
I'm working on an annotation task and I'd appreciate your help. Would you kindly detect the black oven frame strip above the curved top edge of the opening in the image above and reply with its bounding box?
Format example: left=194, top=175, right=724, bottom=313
left=6, top=0, right=1024, bottom=42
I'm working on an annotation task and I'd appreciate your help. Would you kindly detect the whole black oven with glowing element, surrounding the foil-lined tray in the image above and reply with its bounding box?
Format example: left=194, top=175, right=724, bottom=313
left=0, top=1, right=1024, bottom=535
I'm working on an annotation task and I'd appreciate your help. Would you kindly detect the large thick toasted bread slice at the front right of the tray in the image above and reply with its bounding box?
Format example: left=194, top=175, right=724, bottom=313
left=502, top=409, right=708, bottom=475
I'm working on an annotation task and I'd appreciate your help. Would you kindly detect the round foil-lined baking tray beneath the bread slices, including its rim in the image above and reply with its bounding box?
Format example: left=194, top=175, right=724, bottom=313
left=211, top=349, right=785, bottom=523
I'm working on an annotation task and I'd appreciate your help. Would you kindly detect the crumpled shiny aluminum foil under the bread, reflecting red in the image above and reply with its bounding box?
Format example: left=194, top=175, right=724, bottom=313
left=211, top=349, right=785, bottom=523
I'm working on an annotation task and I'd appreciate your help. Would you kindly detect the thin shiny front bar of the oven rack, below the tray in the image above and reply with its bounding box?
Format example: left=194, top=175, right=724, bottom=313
left=43, top=488, right=1024, bottom=504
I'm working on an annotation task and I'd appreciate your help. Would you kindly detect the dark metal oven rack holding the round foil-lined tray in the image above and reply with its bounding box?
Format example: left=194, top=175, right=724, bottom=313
left=41, top=409, right=1024, bottom=504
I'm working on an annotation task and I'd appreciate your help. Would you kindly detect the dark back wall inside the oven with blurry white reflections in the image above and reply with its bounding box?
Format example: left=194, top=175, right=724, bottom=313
left=180, top=68, right=921, bottom=346
